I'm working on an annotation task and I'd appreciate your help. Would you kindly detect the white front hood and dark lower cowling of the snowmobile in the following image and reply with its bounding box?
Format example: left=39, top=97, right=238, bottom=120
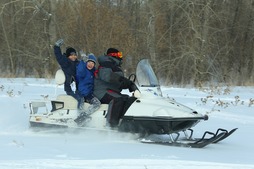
left=119, top=87, right=207, bottom=134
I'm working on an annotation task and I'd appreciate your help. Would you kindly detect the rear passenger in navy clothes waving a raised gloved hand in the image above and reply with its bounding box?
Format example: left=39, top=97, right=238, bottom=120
left=54, top=39, right=80, bottom=102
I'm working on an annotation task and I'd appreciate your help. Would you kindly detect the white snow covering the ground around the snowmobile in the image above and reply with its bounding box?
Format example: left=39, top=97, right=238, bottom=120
left=0, top=78, right=254, bottom=169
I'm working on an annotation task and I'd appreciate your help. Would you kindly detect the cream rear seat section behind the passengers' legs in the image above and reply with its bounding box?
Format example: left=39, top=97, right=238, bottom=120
left=51, top=94, right=78, bottom=112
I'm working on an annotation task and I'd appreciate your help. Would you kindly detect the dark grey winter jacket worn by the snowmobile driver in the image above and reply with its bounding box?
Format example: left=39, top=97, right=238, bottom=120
left=94, top=56, right=129, bottom=100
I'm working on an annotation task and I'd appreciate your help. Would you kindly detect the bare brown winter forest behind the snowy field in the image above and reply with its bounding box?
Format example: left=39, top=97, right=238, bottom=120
left=0, top=0, right=254, bottom=86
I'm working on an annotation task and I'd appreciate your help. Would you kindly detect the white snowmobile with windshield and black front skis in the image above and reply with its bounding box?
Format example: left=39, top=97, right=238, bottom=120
left=29, top=59, right=237, bottom=148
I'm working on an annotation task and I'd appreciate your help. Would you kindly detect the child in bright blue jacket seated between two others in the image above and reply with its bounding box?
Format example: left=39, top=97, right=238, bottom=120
left=74, top=53, right=101, bottom=124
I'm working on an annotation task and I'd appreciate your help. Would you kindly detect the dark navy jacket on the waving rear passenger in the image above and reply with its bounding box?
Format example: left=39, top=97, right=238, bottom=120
left=54, top=46, right=79, bottom=92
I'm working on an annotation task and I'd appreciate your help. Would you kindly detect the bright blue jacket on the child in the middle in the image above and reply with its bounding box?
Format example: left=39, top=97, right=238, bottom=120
left=76, top=60, right=95, bottom=97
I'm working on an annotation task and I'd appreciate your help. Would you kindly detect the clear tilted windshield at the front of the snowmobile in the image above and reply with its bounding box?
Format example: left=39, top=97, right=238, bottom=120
left=136, top=59, right=159, bottom=87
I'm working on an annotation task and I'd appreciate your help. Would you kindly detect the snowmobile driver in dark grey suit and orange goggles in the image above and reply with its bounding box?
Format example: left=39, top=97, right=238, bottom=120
left=94, top=48, right=138, bottom=127
